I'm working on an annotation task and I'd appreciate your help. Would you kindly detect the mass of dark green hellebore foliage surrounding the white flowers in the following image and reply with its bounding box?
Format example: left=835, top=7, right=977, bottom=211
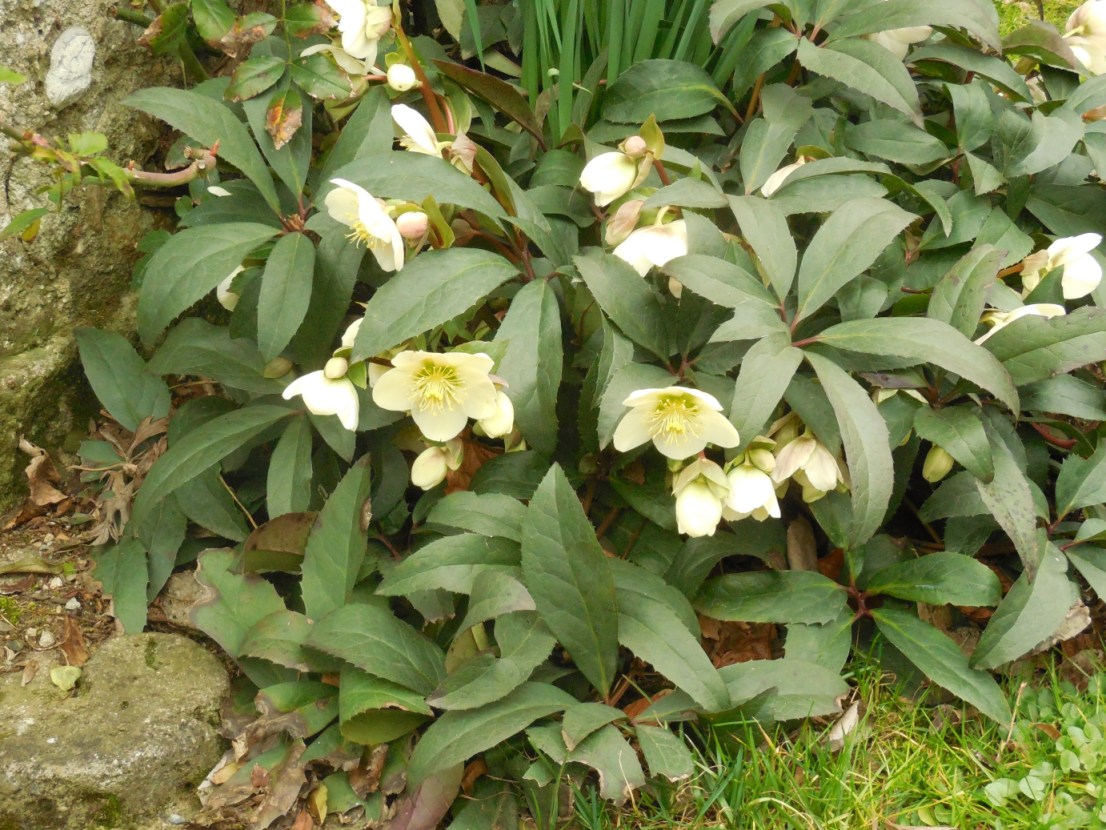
left=81, top=0, right=1106, bottom=826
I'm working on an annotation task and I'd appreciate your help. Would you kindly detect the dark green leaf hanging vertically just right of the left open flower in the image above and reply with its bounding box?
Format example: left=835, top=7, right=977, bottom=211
left=495, top=280, right=564, bottom=456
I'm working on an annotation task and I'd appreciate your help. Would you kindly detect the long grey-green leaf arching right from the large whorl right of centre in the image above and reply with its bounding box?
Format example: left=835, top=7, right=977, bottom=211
left=817, top=318, right=1018, bottom=412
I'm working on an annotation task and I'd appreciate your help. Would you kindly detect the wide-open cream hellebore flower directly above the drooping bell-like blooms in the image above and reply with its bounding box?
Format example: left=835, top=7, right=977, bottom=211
left=614, top=386, right=740, bottom=460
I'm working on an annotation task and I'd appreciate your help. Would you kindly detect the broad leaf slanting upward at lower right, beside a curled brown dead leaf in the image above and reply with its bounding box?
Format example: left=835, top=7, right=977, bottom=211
left=971, top=541, right=1079, bottom=668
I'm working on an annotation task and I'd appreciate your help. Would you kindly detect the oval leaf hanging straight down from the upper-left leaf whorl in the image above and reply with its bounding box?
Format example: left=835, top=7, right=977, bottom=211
left=258, top=234, right=315, bottom=360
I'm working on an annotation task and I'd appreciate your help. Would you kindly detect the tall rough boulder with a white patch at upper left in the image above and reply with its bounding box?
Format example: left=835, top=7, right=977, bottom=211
left=0, top=0, right=179, bottom=511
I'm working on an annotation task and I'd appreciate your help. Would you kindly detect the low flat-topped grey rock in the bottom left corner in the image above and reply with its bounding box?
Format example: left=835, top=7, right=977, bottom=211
left=0, top=634, right=228, bottom=830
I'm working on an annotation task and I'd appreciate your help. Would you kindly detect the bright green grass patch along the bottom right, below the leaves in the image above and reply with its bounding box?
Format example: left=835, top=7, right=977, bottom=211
left=576, top=663, right=1106, bottom=830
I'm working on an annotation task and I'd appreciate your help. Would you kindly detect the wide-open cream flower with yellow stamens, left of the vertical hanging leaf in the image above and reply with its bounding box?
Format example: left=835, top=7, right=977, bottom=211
left=373, top=352, right=500, bottom=440
